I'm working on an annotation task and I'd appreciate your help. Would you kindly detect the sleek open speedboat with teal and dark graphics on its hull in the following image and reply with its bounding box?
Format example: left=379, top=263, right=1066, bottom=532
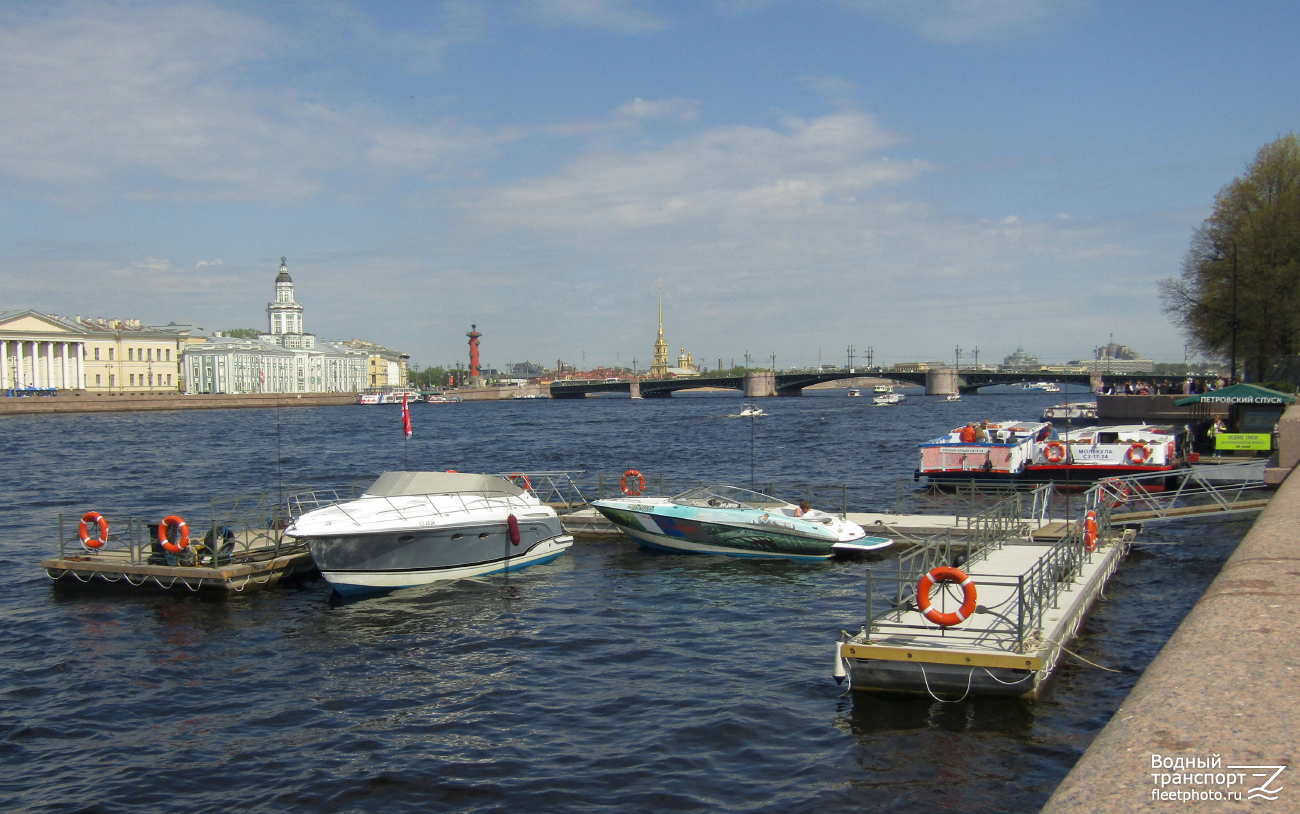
left=592, top=485, right=893, bottom=559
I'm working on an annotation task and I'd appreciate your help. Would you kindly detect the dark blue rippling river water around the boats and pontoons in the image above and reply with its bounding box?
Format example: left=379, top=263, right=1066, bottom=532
left=0, top=390, right=1249, bottom=814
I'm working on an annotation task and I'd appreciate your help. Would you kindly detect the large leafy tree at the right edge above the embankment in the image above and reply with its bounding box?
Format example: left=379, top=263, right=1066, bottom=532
left=1160, top=133, right=1300, bottom=381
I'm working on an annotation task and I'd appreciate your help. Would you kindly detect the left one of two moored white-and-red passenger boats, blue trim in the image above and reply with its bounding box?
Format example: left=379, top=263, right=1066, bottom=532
left=915, top=421, right=1052, bottom=481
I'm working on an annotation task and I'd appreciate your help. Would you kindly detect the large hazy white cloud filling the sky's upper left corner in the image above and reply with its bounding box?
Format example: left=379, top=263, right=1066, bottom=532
left=0, top=3, right=497, bottom=202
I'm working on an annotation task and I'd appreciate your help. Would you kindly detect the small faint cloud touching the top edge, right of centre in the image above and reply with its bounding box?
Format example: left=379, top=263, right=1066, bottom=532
left=842, top=0, right=1083, bottom=43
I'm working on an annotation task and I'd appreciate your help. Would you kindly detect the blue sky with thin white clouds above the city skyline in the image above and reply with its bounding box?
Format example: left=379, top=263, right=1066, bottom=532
left=0, top=0, right=1300, bottom=368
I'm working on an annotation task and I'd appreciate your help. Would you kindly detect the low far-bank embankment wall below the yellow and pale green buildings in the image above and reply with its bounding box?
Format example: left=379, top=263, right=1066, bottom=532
left=0, top=393, right=356, bottom=416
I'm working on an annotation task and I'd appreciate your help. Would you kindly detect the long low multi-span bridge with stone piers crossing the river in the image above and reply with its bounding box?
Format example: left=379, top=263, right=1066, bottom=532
left=551, top=368, right=1213, bottom=398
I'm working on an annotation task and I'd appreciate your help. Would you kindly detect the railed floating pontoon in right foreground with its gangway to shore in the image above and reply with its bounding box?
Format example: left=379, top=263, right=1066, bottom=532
left=836, top=472, right=1268, bottom=701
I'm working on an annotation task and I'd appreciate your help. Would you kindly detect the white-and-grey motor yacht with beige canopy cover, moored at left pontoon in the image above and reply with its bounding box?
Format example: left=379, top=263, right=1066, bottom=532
left=285, top=472, right=573, bottom=596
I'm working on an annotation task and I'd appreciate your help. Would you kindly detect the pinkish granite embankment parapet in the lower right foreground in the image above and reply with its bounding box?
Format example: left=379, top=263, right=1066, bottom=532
left=1043, top=407, right=1300, bottom=814
